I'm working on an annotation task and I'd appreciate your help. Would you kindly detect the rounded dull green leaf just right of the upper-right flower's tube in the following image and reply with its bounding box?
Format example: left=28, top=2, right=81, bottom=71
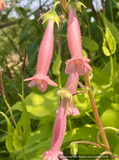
left=81, top=36, right=99, bottom=52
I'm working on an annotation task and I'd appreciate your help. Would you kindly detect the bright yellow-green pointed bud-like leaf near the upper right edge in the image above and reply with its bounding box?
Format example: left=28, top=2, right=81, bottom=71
left=102, top=26, right=116, bottom=56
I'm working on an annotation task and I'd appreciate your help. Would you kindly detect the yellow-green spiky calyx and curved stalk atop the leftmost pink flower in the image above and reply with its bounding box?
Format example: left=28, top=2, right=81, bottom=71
left=37, top=1, right=60, bottom=27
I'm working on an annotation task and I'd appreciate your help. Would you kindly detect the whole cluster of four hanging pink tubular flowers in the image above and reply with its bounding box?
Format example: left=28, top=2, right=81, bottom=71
left=24, top=1, right=92, bottom=160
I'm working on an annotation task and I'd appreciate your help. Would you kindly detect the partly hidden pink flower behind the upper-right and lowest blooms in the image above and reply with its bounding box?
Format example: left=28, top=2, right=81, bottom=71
left=66, top=73, right=80, bottom=116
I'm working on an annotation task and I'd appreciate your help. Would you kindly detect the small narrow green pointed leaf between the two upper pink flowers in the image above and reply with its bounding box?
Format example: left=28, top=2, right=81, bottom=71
left=52, top=47, right=62, bottom=75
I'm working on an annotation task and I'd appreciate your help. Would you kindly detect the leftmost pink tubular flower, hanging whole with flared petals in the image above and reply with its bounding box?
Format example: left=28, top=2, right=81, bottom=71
left=24, top=17, right=57, bottom=92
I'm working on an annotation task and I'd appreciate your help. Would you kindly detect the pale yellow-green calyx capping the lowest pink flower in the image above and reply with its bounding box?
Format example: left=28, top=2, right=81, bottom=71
left=57, top=88, right=72, bottom=103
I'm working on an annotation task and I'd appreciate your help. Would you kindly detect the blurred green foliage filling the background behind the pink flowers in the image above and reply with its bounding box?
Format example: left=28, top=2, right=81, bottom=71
left=0, top=0, right=119, bottom=160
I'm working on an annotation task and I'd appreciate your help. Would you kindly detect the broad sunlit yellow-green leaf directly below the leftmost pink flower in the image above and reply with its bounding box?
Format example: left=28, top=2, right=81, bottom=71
left=12, top=89, right=59, bottom=118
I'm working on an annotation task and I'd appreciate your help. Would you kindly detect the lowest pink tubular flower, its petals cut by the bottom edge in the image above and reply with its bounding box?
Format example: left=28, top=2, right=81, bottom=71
left=43, top=99, right=67, bottom=160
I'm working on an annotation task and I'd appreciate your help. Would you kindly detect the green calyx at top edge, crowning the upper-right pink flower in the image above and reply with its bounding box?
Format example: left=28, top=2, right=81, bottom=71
left=67, top=0, right=87, bottom=12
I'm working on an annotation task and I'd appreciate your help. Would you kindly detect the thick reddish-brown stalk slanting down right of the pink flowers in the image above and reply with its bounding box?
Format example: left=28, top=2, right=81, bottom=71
left=84, top=71, right=110, bottom=151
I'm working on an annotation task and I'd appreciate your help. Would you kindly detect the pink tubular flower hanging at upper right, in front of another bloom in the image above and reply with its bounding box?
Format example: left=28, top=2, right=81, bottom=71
left=65, top=6, right=92, bottom=75
